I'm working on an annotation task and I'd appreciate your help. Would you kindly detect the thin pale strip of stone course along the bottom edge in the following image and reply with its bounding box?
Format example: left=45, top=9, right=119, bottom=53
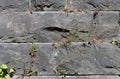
left=11, top=76, right=120, bottom=79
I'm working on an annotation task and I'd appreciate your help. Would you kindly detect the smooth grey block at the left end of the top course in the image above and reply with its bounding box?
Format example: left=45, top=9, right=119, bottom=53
left=0, top=0, right=28, bottom=12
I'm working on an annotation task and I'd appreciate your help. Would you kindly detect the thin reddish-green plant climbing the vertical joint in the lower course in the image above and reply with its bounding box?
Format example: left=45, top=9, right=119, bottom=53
left=14, top=43, right=38, bottom=79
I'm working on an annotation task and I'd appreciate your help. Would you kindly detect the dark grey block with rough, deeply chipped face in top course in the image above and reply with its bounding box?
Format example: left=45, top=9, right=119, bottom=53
left=31, top=0, right=65, bottom=11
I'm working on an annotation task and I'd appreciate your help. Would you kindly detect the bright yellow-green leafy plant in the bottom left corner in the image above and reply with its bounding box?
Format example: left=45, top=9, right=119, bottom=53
left=0, top=64, right=15, bottom=79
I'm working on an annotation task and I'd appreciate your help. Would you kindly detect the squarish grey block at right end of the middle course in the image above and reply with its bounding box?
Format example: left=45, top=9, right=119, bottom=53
left=96, top=11, right=120, bottom=40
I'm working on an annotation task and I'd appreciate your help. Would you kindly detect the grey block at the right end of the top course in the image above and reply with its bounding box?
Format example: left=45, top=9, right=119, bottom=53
left=71, top=0, right=120, bottom=10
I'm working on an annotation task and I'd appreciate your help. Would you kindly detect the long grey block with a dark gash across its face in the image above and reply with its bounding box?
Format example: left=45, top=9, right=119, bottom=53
left=0, top=12, right=92, bottom=42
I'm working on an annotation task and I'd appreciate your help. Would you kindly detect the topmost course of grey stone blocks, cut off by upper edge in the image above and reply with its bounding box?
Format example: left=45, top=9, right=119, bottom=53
left=0, top=0, right=120, bottom=12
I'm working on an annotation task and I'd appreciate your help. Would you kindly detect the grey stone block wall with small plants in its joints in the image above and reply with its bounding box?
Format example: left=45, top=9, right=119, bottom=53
left=0, top=0, right=120, bottom=79
